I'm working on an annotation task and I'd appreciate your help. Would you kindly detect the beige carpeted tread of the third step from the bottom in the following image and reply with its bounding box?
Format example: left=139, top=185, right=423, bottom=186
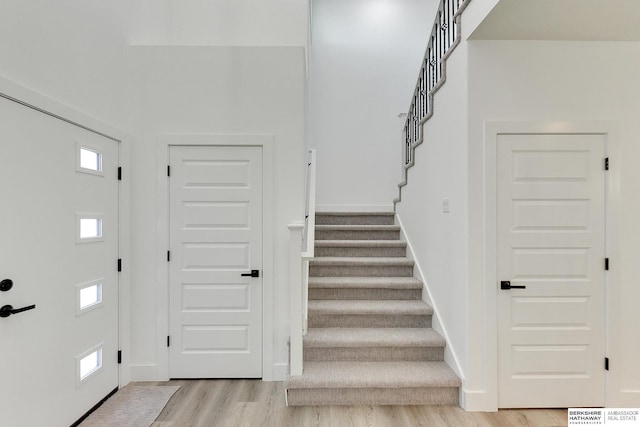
left=308, top=300, right=433, bottom=315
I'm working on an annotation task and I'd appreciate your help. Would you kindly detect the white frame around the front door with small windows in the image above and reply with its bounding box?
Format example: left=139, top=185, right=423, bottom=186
left=0, top=76, right=131, bottom=388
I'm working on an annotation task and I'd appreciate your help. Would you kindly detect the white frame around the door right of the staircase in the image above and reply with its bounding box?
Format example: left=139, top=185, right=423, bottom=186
left=484, top=121, right=621, bottom=410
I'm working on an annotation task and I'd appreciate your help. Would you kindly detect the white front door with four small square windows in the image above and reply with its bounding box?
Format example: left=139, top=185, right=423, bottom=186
left=0, top=98, right=118, bottom=427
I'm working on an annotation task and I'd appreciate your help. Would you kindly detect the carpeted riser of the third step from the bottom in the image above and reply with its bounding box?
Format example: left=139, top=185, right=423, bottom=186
left=308, top=312, right=431, bottom=328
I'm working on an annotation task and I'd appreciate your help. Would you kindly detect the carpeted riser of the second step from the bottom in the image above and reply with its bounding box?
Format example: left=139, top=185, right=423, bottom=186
left=304, top=346, right=444, bottom=362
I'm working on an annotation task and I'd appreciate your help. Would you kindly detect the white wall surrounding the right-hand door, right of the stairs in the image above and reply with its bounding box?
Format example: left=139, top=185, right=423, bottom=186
left=464, top=41, right=640, bottom=407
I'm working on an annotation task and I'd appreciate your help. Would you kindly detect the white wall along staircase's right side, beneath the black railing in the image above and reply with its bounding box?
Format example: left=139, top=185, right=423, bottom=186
left=396, top=43, right=474, bottom=388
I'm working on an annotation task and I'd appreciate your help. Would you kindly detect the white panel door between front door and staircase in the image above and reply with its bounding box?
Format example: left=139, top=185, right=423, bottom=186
left=169, top=146, right=262, bottom=378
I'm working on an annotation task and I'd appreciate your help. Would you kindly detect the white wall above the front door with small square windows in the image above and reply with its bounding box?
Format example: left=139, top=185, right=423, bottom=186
left=0, top=0, right=129, bottom=128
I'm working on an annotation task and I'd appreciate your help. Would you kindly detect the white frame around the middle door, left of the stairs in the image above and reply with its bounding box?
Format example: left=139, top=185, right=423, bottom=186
left=156, top=134, right=274, bottom=381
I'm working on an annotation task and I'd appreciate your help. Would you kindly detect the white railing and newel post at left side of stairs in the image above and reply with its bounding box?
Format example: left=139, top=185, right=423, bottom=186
left=288, top=150, right=316, bottom=375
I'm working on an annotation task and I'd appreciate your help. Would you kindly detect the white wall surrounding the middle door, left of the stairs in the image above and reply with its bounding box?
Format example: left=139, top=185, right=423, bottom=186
left=131, top=46, right=305, bottom=380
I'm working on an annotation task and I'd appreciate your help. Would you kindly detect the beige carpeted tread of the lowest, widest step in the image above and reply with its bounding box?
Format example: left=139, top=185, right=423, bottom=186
left=286, top=362, right=461, bottom=389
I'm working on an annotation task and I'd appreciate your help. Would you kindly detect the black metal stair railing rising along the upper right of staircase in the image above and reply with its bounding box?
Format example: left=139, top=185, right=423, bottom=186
left=393, top=0, right=471, bottom=207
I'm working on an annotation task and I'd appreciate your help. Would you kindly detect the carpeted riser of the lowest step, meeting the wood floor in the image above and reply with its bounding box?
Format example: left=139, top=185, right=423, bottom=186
left=287, top=387, right=458, bottom=406
